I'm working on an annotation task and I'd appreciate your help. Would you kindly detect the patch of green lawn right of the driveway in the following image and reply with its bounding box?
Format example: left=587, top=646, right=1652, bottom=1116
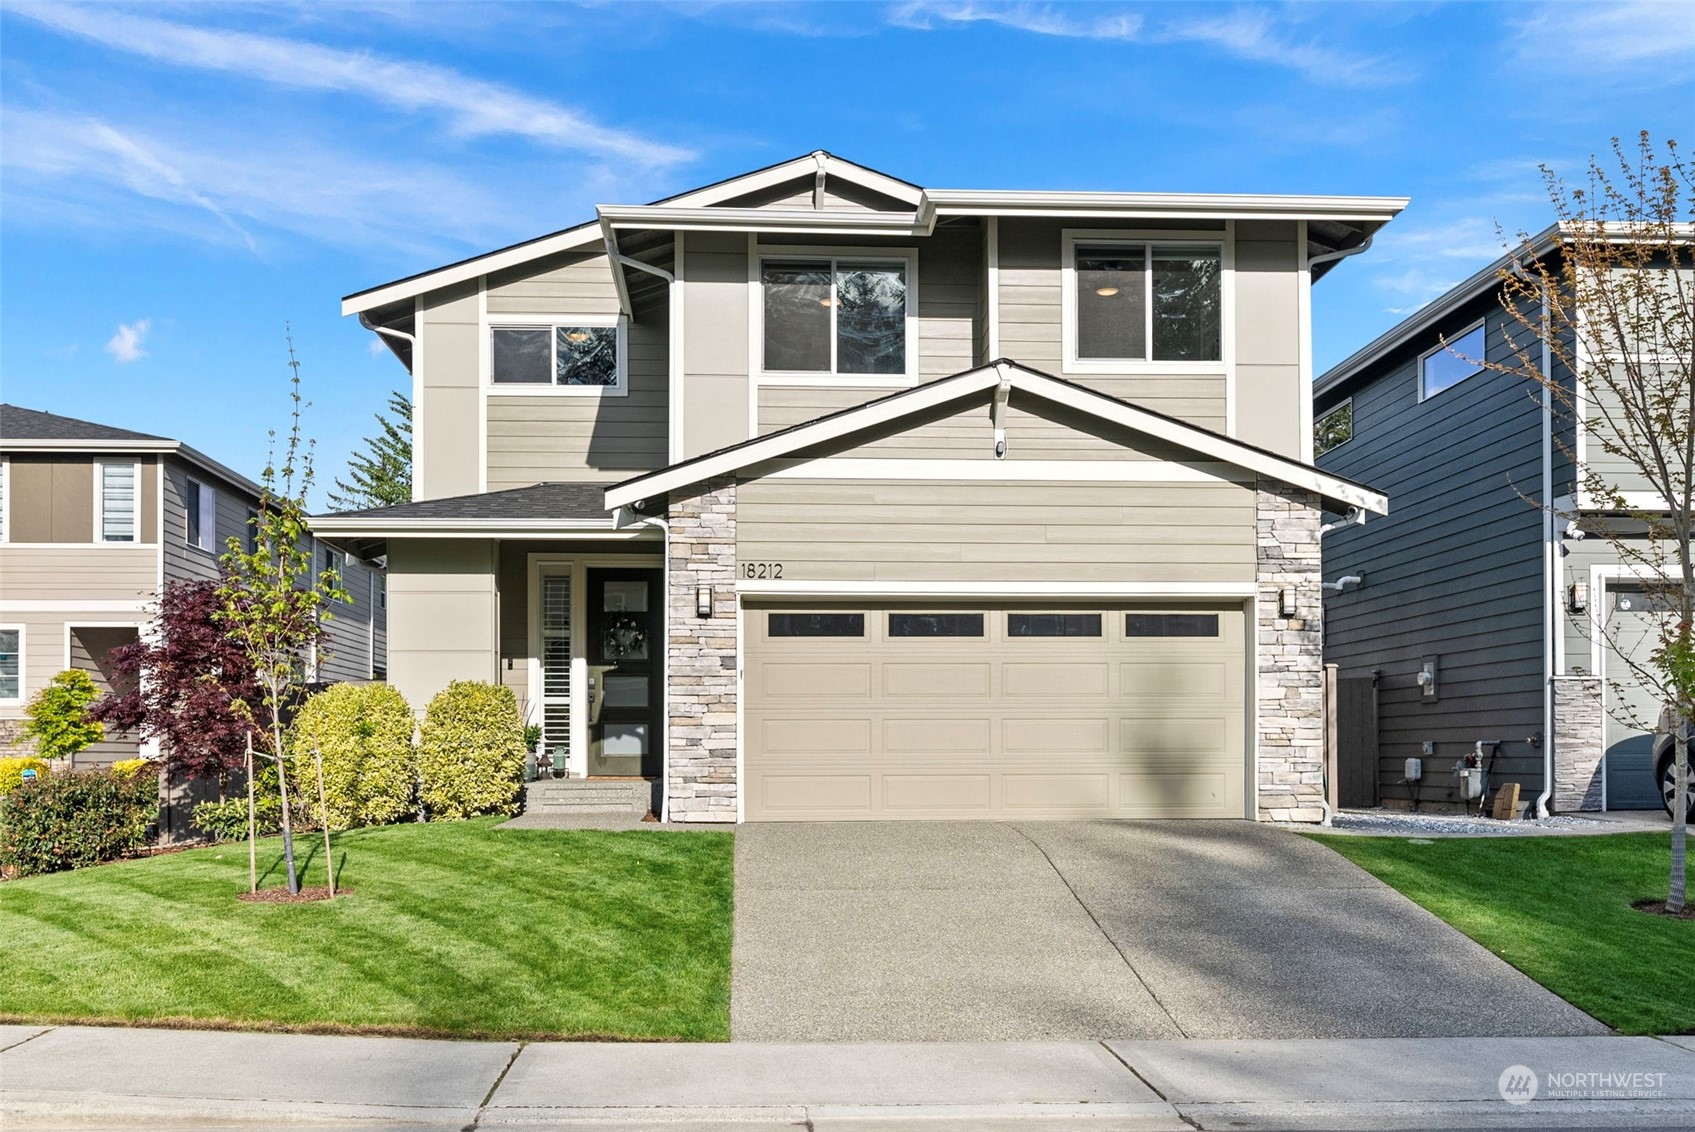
left=1309, top=834, right=1695, bottom=1034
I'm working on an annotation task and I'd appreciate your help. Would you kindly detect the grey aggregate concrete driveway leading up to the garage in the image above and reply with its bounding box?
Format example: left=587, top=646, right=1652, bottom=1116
left=731, top=822, right=1609, bottom=1040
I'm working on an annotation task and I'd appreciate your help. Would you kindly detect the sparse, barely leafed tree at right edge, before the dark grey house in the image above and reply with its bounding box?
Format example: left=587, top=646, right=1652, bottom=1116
left=1488, top=132, right=1695, bottom=913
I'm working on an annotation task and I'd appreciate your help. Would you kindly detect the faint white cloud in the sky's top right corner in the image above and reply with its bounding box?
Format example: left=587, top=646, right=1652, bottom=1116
left=1515, top=0, right=1695, bottom=66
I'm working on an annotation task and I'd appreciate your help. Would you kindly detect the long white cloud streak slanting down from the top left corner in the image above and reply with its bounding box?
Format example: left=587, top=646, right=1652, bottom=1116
left=12, top=3, right=693, bottom=166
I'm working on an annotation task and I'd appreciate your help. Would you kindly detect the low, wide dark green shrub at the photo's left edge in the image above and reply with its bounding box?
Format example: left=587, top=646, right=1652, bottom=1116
left=0, top=769, right=159, bottom=876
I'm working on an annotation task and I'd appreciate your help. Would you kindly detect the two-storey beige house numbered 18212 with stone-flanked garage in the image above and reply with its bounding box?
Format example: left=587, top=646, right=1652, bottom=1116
left=314, top=153, right=1405, bottom=822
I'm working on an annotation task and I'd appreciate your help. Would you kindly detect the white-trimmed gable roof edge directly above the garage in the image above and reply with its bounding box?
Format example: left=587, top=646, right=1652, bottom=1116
left=605, top=359, right=1388, bottom=515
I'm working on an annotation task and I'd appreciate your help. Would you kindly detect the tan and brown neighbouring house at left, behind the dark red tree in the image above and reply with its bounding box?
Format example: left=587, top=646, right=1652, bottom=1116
left=0, top=405, right=386, bottom=766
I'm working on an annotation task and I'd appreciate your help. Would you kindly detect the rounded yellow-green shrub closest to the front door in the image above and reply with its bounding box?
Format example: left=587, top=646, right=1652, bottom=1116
left=419, top=680, right=524, bottom=818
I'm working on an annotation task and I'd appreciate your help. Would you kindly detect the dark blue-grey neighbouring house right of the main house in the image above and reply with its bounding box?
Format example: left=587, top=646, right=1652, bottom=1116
left=1314, top=229, right=1681, bottom=812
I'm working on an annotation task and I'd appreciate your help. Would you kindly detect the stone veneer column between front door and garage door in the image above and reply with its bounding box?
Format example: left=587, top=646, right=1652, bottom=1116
left=664, top=480, right=739, bottom=822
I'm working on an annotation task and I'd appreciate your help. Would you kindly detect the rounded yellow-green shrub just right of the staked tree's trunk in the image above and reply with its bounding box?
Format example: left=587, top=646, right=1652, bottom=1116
left=290, top=685, right=417, bottom=829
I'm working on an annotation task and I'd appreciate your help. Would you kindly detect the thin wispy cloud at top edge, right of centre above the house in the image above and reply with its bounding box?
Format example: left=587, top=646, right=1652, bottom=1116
left=886, top=0, right=1405, bottom=86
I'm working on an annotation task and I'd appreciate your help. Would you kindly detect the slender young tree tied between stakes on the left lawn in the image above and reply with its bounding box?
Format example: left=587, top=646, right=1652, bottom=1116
left=217, top=334, right=351, bottom=893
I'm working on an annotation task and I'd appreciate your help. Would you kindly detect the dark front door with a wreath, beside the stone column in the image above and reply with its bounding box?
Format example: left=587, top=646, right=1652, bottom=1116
left=586, top=569, right=664, bottom=778
